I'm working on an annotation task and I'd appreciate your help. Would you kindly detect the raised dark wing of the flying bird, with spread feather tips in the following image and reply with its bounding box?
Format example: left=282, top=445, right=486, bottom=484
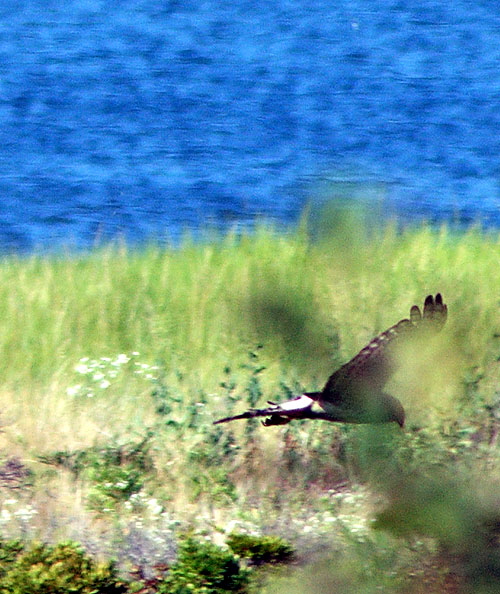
left=320, top=293, right=448, bottom=406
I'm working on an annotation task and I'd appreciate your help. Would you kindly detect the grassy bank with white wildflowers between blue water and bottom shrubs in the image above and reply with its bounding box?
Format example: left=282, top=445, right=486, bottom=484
left=0, top=219, right=500, bottom=592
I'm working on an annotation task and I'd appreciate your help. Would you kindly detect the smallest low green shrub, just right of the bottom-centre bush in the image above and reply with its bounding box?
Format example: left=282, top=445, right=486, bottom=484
left=226, top=533, right=293, bottom=564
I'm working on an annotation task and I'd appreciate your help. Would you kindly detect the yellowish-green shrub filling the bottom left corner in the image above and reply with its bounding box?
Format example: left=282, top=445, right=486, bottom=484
left=0, top=542, right=126, bottom=594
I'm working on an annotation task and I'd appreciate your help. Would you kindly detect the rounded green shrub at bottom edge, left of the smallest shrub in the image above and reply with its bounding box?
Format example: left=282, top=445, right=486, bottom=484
left=158, top=537, right=249, bottom=594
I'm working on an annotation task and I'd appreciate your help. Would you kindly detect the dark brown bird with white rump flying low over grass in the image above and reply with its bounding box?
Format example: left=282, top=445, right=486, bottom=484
left=214, top=293, right=448, bottom=427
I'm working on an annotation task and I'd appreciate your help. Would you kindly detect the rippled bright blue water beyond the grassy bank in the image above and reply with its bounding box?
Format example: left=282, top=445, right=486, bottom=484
left=0, top=0, right=500, bottom=251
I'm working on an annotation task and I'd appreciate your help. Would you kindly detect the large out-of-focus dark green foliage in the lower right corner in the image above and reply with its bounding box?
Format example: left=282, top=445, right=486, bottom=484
left=374, top=442, right=500, bottom=592
